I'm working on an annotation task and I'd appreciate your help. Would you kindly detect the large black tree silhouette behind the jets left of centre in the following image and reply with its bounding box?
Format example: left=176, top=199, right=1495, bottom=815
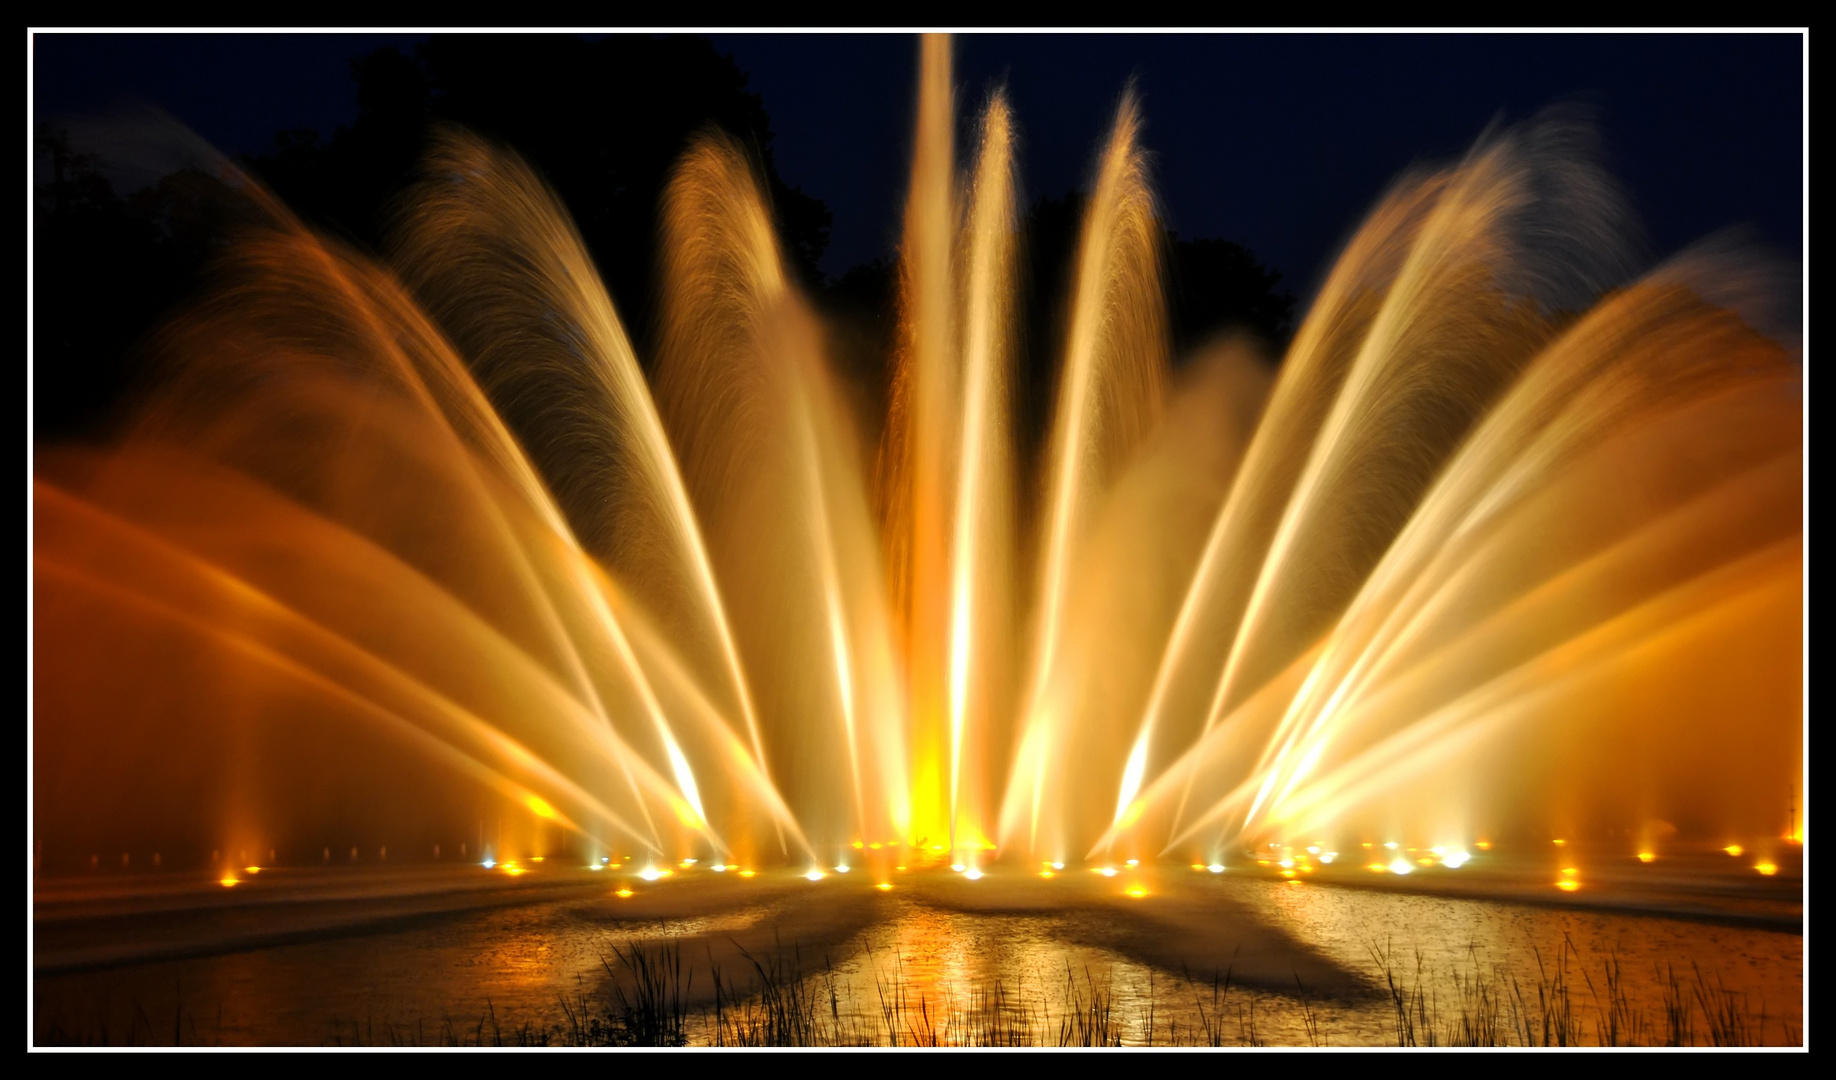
left=250, top=35, right=830, bottom=353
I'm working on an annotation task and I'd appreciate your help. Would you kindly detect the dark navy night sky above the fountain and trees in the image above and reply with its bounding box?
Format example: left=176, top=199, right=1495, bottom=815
left=33, top=33, right=1803, bottom=299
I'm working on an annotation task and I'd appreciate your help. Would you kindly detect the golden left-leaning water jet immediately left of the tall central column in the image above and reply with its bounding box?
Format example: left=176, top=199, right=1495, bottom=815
left=657, top=138, right=911, bottom=859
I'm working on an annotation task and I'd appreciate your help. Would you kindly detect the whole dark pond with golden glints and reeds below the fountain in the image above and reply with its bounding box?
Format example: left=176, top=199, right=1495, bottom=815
left=33, top=852, right=1805, bottom=1045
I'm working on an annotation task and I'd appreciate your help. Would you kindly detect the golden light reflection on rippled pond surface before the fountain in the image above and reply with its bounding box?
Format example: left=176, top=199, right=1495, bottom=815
left=33, top=874, right=1803, bottom=1045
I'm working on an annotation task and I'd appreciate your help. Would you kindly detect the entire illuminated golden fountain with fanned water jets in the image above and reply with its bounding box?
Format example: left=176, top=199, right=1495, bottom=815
left=31, top=40, right=1805, bottom=882
